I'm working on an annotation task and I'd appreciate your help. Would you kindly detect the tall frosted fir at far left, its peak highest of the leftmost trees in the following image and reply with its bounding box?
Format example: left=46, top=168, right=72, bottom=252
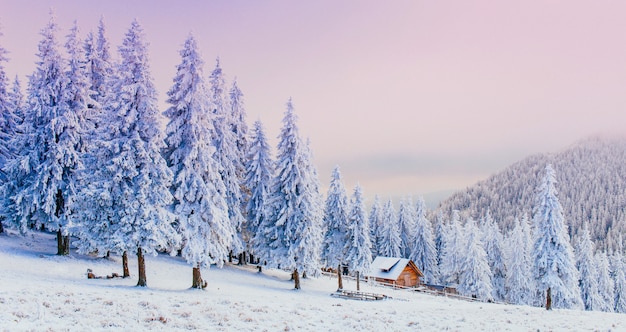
left=5, top=16, right=81, bottom=255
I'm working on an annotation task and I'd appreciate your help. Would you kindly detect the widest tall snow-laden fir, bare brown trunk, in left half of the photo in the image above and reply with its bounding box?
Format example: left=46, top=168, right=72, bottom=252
left=75, top=20, right=179, bottom=286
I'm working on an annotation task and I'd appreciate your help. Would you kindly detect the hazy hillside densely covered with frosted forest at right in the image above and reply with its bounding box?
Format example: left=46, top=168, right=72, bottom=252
left=431, top=138, right=626, bottom=249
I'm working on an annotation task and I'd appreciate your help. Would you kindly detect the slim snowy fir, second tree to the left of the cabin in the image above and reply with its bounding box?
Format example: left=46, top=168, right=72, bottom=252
left=322, top=166, right=349, bottom=270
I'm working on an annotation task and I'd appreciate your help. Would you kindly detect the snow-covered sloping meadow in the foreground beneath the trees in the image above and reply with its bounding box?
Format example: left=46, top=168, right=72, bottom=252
left=0, top=233, right=626, bottom=331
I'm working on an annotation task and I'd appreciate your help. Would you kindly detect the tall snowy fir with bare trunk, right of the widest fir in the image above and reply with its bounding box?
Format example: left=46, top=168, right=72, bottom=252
left=164, top=36, right=236, bottom=288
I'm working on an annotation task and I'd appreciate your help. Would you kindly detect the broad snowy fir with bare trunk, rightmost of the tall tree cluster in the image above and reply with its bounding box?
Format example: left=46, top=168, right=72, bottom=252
left=254, top=99, right=322, bottom=289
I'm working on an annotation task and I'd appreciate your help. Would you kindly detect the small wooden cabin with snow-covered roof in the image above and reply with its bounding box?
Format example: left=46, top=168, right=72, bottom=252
left=365, top=256, right=424, bottom=287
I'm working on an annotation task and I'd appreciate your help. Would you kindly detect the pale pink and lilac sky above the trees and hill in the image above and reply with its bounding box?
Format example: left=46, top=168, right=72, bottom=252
left=0, top=0, right=626, bottom=204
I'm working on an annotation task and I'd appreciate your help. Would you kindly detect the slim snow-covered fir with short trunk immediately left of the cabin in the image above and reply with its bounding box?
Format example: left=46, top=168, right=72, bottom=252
left=346, top=184, right=372, bottom=290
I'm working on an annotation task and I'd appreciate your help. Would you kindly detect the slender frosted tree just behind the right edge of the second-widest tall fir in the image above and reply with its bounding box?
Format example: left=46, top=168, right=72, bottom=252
left=209, top=59, right=245, bottom=260
